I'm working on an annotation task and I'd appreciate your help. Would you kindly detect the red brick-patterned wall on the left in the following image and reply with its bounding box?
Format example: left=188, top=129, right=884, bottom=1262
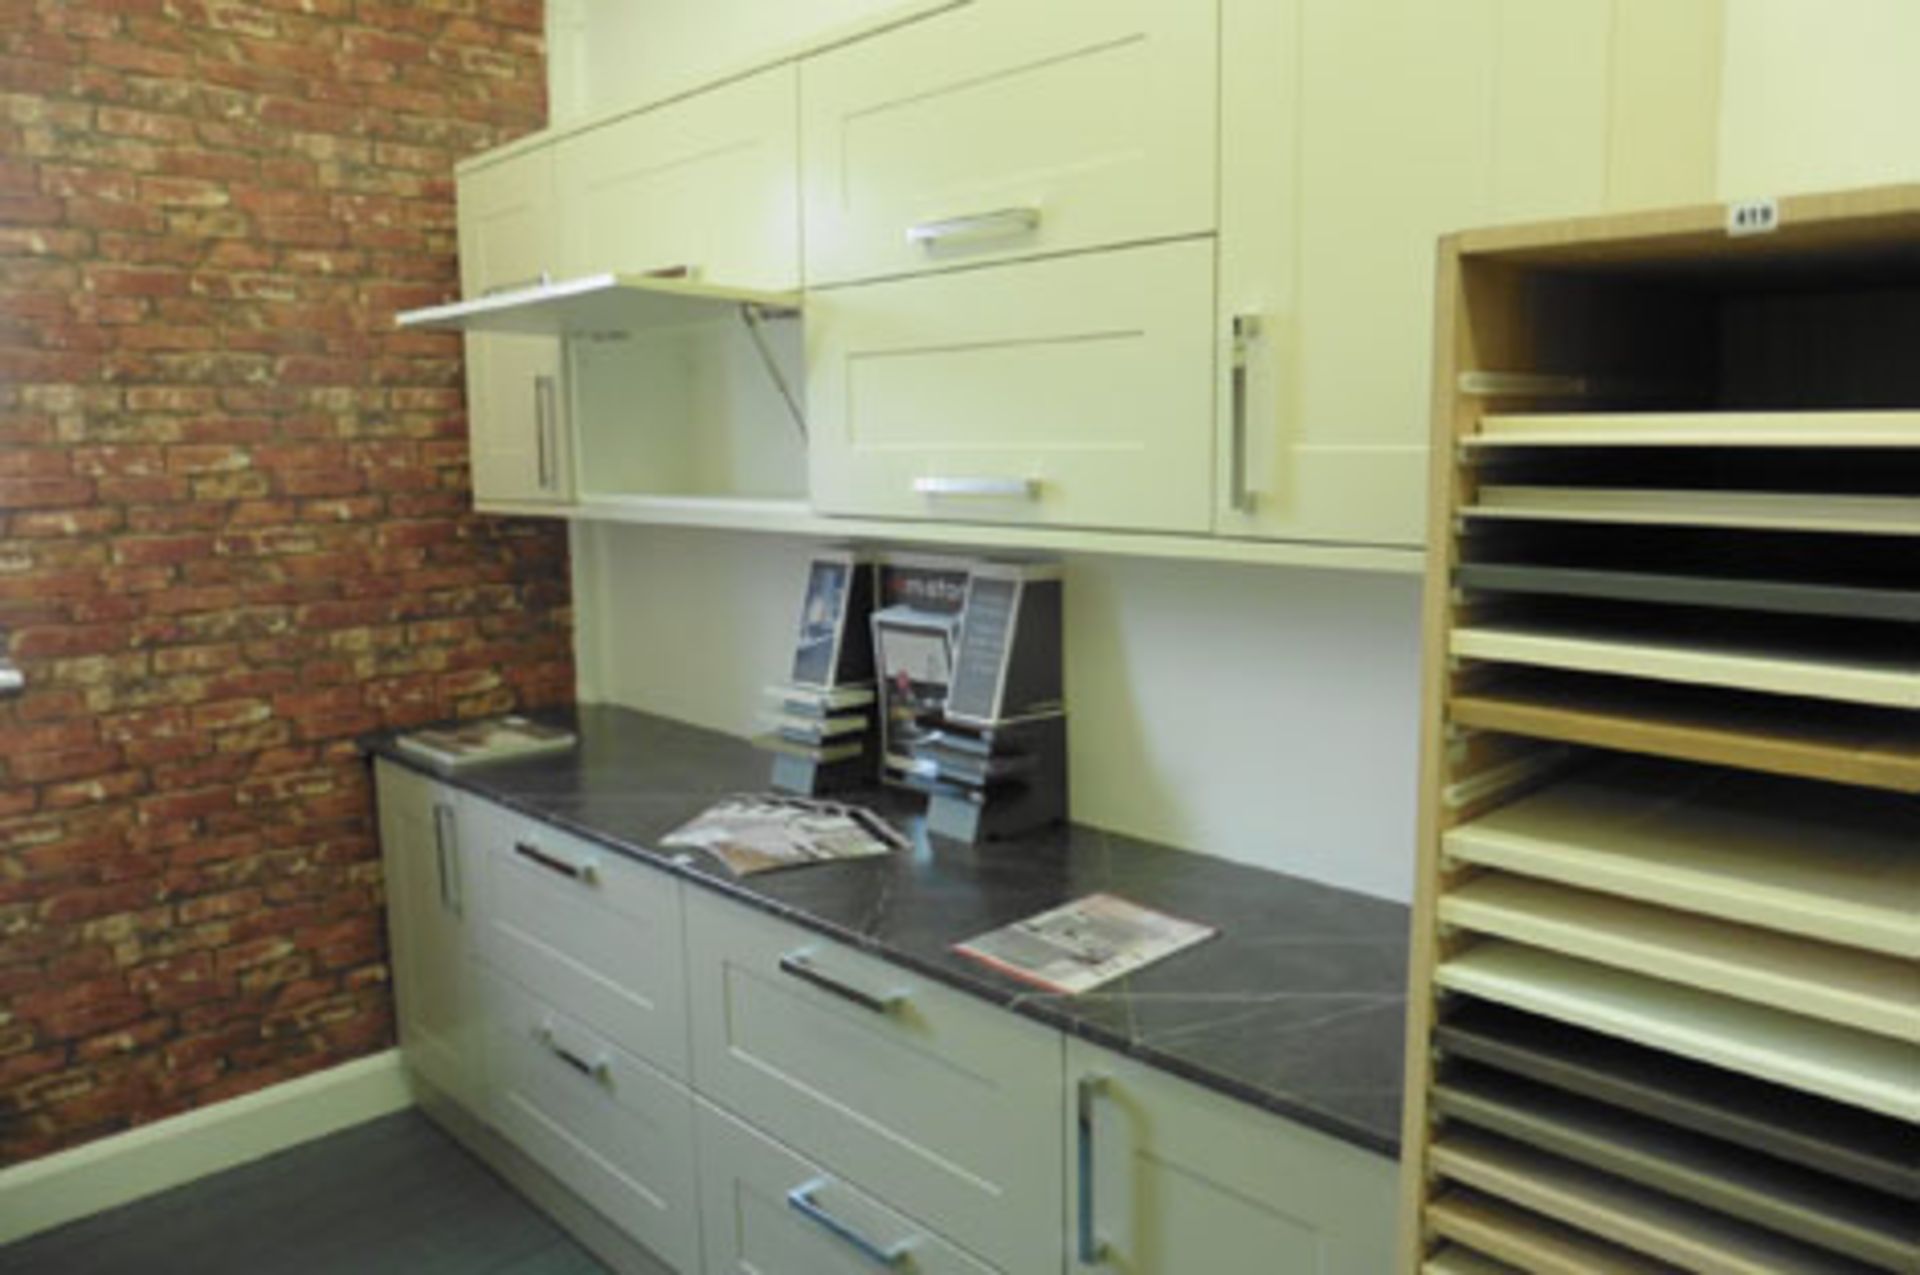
left=0, top=0, right=572, bottom=1162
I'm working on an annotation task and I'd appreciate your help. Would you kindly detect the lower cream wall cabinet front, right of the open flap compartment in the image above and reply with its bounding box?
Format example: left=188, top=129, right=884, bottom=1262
left=806, top=240, right=1213, bottom=532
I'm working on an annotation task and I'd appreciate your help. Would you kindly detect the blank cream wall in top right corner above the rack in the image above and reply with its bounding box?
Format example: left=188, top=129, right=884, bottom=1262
left=1720, top=0, right=1920, bottom=200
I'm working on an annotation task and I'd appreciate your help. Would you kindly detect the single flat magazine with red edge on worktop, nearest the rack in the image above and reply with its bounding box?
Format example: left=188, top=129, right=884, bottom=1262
left=954, top=895, right=1219, bottom=997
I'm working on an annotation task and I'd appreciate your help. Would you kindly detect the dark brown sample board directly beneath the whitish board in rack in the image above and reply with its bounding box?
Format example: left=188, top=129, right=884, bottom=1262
left=1434, top=1002, right=1920, bottom=1208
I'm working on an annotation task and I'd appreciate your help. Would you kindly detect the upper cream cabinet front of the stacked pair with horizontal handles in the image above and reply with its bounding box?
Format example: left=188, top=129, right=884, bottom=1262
left=801, top=0, right=1219, bottom=286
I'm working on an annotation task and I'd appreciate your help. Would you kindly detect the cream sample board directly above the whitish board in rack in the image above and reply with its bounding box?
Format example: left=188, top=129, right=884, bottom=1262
left=1440, top=872, right=1920, bottom=1044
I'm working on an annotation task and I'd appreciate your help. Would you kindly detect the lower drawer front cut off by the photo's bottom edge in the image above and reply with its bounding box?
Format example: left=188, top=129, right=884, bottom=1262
left=697, top=1100, right=995, bottom=1275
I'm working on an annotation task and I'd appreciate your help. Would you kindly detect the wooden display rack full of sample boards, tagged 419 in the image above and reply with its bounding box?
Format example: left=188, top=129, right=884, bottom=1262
left=1400, top=186, right=1920, bottom=1273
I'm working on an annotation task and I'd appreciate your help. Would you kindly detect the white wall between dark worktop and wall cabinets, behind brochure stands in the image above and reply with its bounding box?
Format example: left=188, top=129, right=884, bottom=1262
left=574, top=526, right=1419, bottom=901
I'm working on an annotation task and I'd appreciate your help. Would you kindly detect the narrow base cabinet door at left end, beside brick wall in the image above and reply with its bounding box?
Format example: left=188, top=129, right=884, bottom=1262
left=376, top=762, right=486, bottom=1110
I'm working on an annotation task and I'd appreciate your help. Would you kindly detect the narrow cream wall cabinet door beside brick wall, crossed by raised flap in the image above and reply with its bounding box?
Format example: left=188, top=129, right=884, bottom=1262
left=459, top=146, right=572, bottom=505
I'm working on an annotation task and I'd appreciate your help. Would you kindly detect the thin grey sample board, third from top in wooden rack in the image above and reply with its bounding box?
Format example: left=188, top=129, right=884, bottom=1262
left=1453, top=563, right=1920, bottom=624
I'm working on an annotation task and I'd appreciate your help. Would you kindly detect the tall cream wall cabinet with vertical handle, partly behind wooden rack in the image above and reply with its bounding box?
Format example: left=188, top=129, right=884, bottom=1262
left=1215, top=0, right=1716, bottom=545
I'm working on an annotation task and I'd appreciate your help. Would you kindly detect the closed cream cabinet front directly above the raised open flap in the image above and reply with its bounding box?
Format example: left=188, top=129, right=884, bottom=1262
left=557, top=65, right=801, bottom=290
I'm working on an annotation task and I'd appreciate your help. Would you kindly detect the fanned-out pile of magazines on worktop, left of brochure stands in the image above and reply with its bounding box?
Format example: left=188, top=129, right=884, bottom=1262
left=660, top=795, right=910, bottom=876
